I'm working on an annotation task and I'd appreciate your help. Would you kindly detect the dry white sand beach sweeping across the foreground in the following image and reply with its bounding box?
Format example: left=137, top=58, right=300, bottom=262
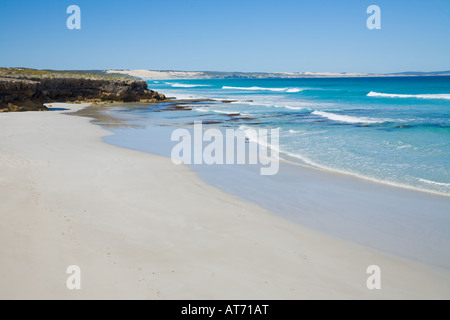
left=0, top=104, right=450, bottom=299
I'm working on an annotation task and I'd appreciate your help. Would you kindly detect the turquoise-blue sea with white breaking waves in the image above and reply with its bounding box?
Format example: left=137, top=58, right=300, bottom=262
left=112, top=77, right=450, bottom=195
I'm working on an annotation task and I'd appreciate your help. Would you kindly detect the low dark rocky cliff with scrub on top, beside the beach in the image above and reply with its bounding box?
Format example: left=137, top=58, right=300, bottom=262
left=0, top=69, right=166, bottom=112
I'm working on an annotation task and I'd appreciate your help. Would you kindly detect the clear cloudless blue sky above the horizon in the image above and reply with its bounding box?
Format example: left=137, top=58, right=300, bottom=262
left=0, top=0, right=450, bottom=72
